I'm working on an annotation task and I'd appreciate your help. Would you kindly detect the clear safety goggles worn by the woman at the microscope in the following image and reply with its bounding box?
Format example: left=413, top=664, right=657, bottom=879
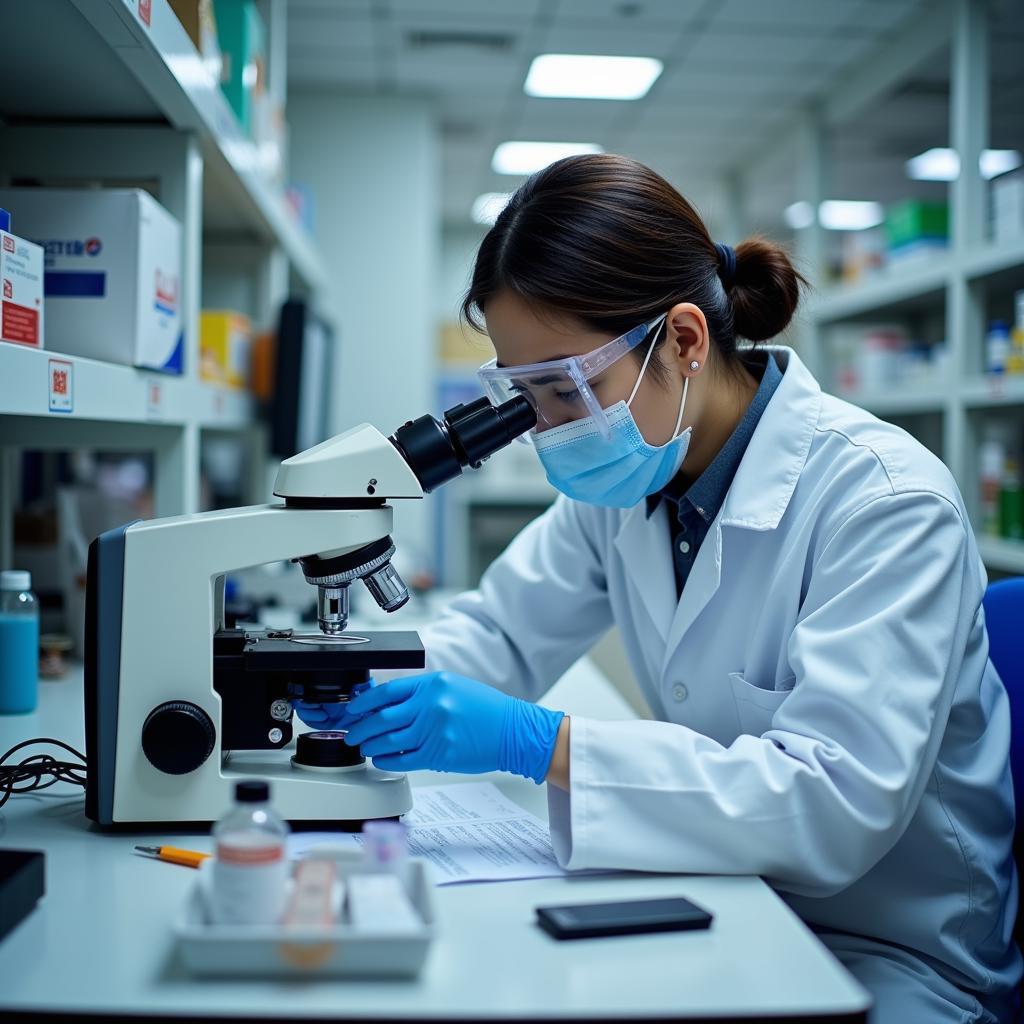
left=477, top=313, right=666, bottom=441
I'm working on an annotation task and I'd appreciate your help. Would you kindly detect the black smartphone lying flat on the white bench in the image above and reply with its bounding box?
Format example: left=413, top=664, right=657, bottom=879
left=537, top=897, right=713, bottom=939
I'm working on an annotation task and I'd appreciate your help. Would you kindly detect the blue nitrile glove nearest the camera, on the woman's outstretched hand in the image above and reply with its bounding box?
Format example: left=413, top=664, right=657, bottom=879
left=345, top=672, right=564, bottom=782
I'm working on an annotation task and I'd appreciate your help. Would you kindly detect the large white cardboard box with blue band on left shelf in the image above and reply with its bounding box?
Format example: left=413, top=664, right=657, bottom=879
left=0, top=188, right=184, bottom=374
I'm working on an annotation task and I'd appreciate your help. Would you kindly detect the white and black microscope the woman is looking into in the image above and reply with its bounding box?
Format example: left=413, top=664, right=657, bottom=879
left=85, top=396, right=536, bottom=826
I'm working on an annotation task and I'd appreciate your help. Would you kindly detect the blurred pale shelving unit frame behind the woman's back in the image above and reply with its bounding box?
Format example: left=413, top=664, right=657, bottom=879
left=778, top=0, right=1024, bottom=572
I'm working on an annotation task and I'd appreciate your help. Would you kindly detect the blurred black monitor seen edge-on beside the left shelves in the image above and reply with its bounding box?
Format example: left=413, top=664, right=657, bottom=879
left=269, top=299, right=334, bottom=459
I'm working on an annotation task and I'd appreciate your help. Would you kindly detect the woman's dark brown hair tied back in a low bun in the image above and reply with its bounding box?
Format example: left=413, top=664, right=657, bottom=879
left=462, top=149, right=806, bottom=373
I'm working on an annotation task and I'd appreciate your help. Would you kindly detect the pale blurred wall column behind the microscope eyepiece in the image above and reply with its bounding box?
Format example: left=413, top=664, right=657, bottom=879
left=288, top=92, right=440, bottom=560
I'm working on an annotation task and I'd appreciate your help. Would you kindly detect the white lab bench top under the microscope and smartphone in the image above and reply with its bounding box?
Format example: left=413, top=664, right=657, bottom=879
left=0, top=659, right=869, bottom=1024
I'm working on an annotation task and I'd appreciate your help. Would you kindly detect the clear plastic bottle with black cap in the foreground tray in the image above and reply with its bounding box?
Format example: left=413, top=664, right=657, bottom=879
left=212, top=780, right=288, bottom=925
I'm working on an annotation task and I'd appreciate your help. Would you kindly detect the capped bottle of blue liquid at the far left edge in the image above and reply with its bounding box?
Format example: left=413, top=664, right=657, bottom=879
left=0, top=569, right=39, bottom=715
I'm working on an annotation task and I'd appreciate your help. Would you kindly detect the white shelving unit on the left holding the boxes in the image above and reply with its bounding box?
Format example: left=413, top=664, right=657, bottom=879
left=0, top=0, right=327, bottom=566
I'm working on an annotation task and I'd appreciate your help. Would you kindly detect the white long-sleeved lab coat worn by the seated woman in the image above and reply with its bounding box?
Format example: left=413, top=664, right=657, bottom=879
left=424, top=348, right=1021, bottom=1021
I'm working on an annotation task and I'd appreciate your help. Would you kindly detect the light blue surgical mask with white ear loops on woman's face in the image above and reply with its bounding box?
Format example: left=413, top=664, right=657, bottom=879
left=534, top=331, right=690, bottom=509
